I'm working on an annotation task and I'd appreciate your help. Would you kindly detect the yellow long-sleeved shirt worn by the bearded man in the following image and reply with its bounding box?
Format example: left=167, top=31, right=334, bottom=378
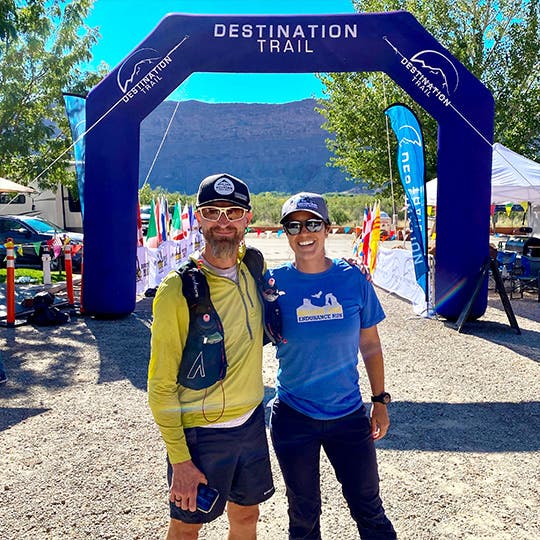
left=148, top=253, right=264, bottom=463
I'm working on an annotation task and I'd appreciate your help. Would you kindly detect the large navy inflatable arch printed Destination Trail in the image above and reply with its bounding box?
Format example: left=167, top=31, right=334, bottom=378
left=83, top=12, right=494, bottom=319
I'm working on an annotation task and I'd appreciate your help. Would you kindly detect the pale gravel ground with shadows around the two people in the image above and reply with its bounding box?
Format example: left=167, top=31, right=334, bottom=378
left=0, top=236, right=540, bottom=540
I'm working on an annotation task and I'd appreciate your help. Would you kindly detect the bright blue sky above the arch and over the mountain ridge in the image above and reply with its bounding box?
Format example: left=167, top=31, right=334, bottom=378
left=87, top=0, right=355, bottom=103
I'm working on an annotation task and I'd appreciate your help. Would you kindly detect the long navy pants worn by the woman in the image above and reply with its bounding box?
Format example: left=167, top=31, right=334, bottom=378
left=270, top=399, right=397, bottom=540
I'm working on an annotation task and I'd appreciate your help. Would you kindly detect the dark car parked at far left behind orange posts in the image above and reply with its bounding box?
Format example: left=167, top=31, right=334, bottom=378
left=0, top=216, right=83, bottom=271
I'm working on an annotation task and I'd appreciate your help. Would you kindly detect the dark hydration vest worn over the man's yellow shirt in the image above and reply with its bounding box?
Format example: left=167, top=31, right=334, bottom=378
left=177, top=247, right=282, bottom=390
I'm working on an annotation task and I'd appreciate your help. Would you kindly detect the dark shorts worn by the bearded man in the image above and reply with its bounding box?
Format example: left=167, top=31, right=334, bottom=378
left=167, top=404, right=275, bottom=523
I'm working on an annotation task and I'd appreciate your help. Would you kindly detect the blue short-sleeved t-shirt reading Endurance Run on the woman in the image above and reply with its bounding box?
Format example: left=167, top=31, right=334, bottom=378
left=265, top=259, right=384, bottom=419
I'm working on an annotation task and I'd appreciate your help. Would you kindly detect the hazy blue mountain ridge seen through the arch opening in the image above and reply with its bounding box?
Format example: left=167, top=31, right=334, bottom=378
left=139, top=99, right=368, bottom=194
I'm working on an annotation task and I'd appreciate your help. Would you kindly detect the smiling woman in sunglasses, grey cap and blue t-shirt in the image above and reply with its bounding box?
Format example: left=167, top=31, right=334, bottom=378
left=265, top=193, right=396, bottom=540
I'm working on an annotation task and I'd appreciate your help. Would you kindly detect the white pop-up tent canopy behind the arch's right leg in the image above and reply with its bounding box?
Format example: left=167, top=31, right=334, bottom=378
left=426, top=143, right=540, bottom=206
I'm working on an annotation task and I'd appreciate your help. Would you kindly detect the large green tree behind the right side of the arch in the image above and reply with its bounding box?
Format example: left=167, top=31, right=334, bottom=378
left=319, top=0, right=540, bottom=194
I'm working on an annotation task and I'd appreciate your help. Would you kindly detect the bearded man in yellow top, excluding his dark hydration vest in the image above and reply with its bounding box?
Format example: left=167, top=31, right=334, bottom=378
left=148, top=173, right=274, bottom=540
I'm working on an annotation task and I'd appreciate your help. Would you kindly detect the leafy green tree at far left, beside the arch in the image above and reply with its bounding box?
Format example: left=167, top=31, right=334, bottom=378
left=0, top=0, right=101, bottom=193
